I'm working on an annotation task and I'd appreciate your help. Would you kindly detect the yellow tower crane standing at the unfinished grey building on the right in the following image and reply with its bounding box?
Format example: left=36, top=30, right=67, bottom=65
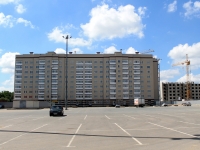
left=172, top=54, right=191, bottom=100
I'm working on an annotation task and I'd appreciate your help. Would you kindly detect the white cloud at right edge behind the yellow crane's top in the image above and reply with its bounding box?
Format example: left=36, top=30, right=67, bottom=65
left=168, top=42, right=200, bottom=69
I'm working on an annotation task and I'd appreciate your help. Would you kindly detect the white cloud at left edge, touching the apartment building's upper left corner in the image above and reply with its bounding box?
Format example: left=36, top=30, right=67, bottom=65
left=0, top=52, right=19, bottom=73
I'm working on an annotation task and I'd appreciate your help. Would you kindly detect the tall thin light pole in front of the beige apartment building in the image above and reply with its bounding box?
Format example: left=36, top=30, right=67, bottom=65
left=63, top=35, right=71, bottom=110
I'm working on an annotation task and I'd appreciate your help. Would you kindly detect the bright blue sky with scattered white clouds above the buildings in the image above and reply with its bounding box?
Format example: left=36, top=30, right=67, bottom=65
left=0, top=0, right=200, bottom=91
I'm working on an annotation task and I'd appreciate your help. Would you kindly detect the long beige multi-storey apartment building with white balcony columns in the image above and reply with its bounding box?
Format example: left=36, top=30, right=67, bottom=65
left=14, top=52, right=159, bottom=106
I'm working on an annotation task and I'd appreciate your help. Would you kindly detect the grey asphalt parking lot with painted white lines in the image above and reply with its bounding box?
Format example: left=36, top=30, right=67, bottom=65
left=0, top=106, right=200, bottom=150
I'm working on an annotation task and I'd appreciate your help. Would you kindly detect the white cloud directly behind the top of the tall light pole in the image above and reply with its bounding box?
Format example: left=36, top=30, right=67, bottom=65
left=47, top=27, right=92, bottom=46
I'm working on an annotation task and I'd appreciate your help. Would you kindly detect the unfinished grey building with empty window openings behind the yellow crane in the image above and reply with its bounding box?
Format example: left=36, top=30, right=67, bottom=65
left=160, top=82, right=200, bottom=101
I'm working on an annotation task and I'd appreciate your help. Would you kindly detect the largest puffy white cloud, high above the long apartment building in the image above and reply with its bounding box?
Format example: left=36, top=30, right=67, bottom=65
left=81, top=4, right=145, bottom=40
